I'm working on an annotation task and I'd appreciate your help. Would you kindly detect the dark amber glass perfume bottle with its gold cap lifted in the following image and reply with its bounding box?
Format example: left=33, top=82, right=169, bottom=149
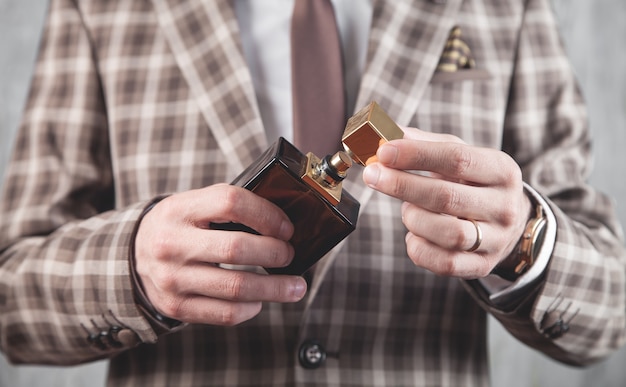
left=211, top=102, right=403, bottom=275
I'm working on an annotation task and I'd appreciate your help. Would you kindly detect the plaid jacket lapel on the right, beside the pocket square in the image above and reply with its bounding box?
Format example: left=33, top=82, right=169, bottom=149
left=357, top=0, right=462, bottom=126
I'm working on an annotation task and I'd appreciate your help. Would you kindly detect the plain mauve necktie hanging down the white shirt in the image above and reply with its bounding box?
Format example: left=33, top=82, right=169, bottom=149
left=291, top=0, right=345, bottom=158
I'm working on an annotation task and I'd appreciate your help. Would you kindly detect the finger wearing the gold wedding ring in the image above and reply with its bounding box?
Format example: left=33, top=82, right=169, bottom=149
left=402, top=202, right=489, bottom=253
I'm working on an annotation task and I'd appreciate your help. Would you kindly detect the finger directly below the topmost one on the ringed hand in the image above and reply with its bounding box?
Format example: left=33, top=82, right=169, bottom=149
left=363, top=163, right=502, bottom=220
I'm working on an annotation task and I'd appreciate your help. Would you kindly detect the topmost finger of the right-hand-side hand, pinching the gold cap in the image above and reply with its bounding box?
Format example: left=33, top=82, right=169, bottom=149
left=376, top=140, right=521, bottom=185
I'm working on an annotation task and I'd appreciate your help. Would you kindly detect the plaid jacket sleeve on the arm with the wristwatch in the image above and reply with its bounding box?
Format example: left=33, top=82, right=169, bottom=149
left=466, top=0, right=626, bottom=365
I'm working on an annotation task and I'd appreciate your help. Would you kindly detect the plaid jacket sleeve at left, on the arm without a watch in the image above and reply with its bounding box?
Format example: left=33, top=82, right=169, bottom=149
left=0, top=0, right=161, bottom=364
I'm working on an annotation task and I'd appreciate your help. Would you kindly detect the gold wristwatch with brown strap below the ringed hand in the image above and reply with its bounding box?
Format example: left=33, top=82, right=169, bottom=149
left=493, top=198, right=546, bottom=281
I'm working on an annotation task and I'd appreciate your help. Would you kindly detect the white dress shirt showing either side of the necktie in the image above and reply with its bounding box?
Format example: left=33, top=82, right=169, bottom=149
left=235, top=0, right=372, bottom=143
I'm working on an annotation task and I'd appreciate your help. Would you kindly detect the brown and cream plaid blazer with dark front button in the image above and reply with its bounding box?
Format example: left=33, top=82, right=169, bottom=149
left=0, top=0, right=626, bottom=386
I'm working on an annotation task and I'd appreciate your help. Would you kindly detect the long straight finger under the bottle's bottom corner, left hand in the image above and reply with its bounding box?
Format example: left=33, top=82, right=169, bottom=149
left=163, top=265, right=307, bottom=303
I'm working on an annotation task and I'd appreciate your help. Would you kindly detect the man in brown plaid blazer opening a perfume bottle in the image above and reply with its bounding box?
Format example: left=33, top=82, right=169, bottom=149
left=0, top=0, right=624, bottom=385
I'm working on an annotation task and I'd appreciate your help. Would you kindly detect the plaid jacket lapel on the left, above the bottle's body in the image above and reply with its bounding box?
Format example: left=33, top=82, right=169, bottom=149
left=153, top=0, right=268, bottom=171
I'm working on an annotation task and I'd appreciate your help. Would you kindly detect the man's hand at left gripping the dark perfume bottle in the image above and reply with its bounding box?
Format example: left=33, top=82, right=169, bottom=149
left=135, top=184, right=306, bottom=325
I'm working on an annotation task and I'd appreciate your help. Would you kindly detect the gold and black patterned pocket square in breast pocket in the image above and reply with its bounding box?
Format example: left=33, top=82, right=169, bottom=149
left=432, top=27, right=491, bottom=82
